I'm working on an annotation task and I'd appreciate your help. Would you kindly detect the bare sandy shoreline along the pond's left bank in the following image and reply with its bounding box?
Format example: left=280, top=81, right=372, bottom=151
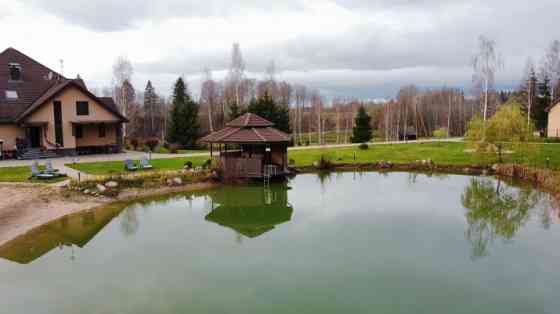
left=0, top=182, right=218, bottom=246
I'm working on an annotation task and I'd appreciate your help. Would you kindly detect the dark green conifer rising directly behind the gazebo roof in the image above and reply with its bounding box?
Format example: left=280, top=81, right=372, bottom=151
left=247, top=92, right=290, bottom=134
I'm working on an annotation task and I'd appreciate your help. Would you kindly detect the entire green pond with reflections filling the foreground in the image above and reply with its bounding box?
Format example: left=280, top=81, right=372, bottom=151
left=0, top=173, right=560, bottom=314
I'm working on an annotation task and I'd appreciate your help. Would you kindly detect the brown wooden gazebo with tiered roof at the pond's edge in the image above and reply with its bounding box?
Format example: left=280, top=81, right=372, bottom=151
left=201, top=113, right=290, bottom=179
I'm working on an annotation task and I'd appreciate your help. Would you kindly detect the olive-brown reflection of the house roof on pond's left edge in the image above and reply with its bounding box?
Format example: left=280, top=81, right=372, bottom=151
left=0, top=207, right=120, bottom=264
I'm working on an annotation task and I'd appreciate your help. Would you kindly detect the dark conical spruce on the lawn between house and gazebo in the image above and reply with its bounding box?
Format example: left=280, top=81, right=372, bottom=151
left=167, top=78, right=200, bottom=147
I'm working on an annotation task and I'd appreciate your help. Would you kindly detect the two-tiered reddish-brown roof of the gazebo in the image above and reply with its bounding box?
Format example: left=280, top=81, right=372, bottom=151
left=201, top=113, right=290, bottom=144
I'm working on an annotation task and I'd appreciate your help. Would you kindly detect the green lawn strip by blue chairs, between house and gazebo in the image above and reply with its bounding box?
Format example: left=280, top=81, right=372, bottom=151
left=66, top=156, right=208, bottom=175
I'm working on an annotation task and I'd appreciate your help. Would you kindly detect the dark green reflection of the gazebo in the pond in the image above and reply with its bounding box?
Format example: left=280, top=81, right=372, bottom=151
left=206, top=185, right=293, bottom=241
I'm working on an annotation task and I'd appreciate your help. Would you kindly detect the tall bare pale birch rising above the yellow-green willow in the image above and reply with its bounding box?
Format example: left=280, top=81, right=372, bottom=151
left=473, top=36, right=503, bottom=129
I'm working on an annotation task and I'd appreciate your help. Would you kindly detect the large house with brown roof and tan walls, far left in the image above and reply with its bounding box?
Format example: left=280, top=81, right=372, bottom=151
left=0, top=48, right=127, bottom=159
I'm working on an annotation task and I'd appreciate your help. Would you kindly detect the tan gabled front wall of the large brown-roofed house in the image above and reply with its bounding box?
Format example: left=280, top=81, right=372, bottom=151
left=26, top=87, right=119, bottom=149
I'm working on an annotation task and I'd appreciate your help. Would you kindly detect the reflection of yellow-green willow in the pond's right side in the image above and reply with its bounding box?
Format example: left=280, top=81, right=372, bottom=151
left=461, top=178, right=542, bottom=259
